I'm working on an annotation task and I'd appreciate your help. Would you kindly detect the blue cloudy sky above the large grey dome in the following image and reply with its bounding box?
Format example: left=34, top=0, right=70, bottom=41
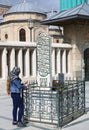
left=9, top=0, right=60, bottom=11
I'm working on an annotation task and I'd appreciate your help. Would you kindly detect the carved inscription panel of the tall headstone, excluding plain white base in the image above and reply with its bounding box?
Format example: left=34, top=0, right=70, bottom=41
left=37, top=33, right=50, bottom=77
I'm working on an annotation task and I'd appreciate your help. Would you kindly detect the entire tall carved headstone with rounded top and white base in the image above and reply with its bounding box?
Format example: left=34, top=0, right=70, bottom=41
left=37, top=32, right=52, bottom=87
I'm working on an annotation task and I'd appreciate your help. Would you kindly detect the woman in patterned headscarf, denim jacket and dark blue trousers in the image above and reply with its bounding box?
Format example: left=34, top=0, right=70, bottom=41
left=10, top=67, right=26, bottom=127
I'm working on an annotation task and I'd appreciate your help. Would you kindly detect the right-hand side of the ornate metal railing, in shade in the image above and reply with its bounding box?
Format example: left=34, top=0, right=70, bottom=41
left=58, top=81, right=85, bottom=127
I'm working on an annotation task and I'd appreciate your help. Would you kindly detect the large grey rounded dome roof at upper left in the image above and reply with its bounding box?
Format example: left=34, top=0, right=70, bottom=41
left=5, top=2, right=46, bottom=15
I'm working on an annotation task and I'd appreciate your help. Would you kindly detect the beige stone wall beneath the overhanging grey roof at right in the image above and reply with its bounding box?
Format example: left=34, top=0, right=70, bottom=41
left=64, top=22, right=89, bottom=78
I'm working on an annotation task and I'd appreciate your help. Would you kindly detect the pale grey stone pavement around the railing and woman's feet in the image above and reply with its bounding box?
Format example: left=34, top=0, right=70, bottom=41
left=0, top=83, right=89, bottom=130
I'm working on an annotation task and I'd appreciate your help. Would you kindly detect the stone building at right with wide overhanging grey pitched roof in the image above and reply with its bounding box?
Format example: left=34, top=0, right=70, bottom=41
left=42, top=3, right=89, bottom=80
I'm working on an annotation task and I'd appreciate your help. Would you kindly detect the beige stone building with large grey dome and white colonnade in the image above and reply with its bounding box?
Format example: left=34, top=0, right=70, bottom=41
left=0, top=1, right=72, bottom=91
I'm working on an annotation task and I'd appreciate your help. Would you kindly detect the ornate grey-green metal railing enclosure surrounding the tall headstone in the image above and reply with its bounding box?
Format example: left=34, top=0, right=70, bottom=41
left=23, top=81, right=85, bottom=127
